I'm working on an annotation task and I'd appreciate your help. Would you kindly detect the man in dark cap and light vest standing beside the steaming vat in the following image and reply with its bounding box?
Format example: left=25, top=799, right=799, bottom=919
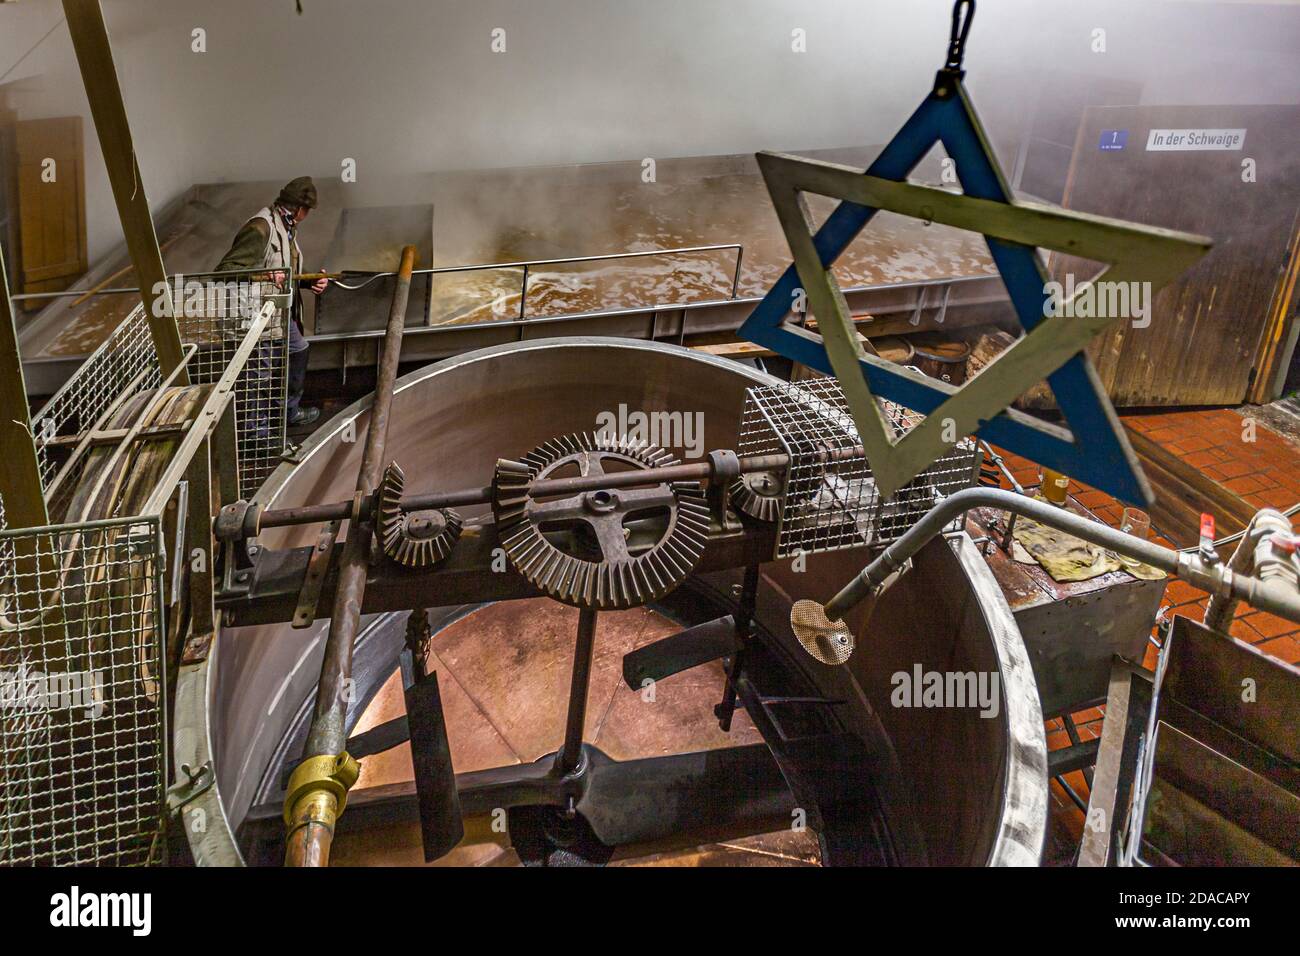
left=216, top=176, right=329, bottom=425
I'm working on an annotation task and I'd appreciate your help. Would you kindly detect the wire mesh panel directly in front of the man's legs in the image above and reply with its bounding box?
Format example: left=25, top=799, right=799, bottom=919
left=173, top=273, right=293, bottom=498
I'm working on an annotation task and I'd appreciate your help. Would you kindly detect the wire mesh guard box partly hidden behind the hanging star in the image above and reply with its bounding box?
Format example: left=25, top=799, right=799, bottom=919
left=737, top=377, right=979, bottom=558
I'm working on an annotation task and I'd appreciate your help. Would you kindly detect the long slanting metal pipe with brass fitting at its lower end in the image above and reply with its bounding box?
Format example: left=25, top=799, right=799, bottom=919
left=285, top=246, right=416, bottom=866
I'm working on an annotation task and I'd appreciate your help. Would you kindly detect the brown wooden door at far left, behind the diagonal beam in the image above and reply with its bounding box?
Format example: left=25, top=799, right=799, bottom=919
left=14, top=116, right=86, bottom=303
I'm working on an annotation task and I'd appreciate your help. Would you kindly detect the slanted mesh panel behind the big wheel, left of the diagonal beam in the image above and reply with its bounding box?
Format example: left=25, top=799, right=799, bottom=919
left=31, top=306, right=163, bottom=488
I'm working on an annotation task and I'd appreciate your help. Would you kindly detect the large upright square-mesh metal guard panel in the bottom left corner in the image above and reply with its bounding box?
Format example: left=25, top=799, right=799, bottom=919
left=0, top=518, right=166, bottom=866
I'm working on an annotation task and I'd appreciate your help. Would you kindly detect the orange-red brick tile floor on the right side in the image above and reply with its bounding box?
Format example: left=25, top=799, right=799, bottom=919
left=1001, top=408, right=1300, bottom=862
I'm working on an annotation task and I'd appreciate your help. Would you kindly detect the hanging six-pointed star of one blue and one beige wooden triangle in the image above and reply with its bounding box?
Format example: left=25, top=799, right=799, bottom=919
left=738, top=68, right=1210, bottom=506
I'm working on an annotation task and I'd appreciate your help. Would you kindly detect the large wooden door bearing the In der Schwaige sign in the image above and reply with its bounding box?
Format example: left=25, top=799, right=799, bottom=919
left=1052, top=105, right=1300, bottom=406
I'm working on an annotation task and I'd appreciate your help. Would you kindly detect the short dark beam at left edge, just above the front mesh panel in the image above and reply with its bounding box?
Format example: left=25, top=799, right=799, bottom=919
left=0, top=256, right=49, bottom=529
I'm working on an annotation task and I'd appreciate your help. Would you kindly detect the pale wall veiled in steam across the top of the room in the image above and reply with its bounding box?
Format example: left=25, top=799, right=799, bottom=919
left=0, top=0, right=1300, bottom=264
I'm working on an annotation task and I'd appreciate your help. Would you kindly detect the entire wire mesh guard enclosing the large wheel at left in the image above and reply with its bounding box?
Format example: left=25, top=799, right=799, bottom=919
left=0, top=303, right=276, bottom=866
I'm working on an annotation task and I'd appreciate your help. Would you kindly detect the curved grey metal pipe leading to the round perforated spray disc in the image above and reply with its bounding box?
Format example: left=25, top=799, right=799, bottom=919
left=826, top=488, right=1300, bottom=620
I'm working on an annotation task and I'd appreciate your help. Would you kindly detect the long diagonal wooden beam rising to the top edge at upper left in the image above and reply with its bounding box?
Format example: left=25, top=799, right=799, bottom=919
left=64, top=0, right=189, bottom=385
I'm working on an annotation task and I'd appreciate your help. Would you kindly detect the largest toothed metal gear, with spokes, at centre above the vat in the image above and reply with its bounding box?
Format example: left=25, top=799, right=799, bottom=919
left=493, top=433, right=709, bottom=610
